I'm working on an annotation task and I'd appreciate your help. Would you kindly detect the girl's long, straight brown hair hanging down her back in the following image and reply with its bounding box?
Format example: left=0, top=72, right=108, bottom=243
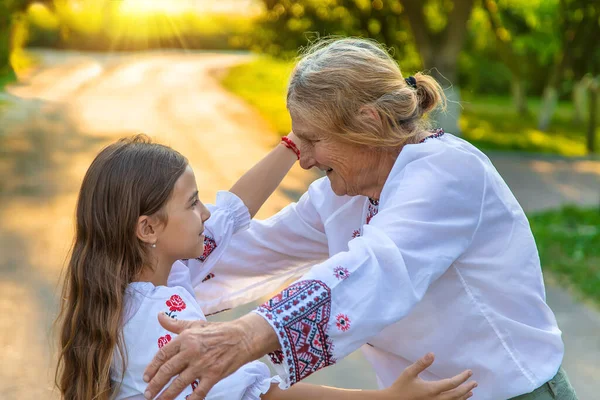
left=56, top=135, right=187, bottom=400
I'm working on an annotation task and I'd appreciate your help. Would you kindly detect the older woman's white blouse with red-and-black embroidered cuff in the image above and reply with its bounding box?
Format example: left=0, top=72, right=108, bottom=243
left=194, top=134, right=563, bottom=399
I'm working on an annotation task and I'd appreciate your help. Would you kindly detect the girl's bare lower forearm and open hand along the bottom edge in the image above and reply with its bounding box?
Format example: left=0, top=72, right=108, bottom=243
left=261, top=354, right=477, bottom=400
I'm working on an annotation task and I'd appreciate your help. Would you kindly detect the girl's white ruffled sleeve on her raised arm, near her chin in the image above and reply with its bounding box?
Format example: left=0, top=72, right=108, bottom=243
left=182, top=191, right=250, bottom=286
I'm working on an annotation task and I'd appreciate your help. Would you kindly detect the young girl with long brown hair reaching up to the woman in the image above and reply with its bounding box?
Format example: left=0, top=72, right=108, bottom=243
left=57, top=134, right=475, bottom=400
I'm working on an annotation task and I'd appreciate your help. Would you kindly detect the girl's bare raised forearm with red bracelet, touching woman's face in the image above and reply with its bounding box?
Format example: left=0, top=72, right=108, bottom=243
left=229, top=132, right=298, bottom=217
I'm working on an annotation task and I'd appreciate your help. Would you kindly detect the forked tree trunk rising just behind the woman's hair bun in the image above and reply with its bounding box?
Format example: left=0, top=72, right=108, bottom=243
left=402, top=0, right=474, bottom=133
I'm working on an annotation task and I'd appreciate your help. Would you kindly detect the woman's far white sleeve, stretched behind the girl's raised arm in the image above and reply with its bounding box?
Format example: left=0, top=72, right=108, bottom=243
left=194, top=181, right=329, bottom=314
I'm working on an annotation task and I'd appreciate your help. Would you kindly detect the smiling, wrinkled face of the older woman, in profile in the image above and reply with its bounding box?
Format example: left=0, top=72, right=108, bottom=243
left=292, top=116, right=389, bottom=197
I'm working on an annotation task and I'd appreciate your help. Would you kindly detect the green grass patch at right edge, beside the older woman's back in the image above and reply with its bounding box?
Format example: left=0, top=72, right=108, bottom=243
left=529, top=206, right=600, bottom=305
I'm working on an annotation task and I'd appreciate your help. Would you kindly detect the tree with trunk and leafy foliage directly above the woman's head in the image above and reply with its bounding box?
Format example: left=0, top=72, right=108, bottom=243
left=258, top=0, right=474, bottom=133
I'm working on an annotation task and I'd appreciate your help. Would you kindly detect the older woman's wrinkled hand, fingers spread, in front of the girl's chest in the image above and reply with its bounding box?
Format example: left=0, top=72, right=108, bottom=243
left=144, top=313, right=279, bottom=400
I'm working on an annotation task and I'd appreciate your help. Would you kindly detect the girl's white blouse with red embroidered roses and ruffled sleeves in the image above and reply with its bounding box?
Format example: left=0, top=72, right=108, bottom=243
left=111, top=192, right=280, bottom=400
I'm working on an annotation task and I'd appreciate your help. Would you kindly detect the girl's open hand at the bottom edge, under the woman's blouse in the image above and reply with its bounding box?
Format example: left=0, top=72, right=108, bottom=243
left=382, top=353, right=477, bottom=400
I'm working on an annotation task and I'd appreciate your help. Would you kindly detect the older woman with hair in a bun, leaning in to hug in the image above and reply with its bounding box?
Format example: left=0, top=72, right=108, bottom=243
left=145, top=39, right=576, bottom=400
